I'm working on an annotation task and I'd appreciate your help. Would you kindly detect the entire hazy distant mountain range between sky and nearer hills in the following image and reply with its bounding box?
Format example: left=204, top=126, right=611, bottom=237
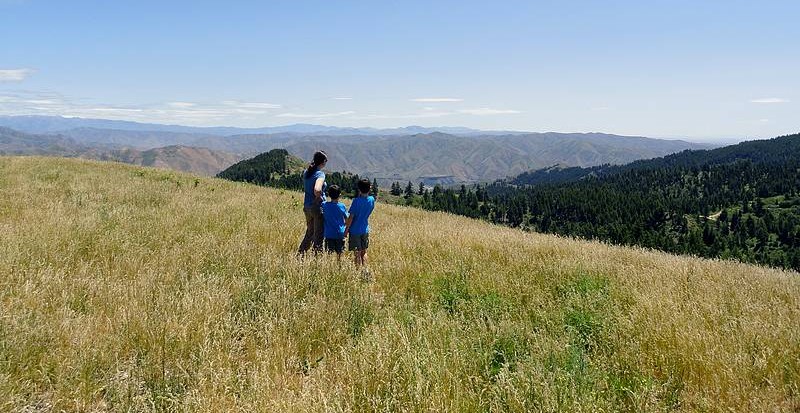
left=0, top=116, right=710, bottom=184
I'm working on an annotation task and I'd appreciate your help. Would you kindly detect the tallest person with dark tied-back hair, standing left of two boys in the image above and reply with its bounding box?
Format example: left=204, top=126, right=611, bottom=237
left=297, top=151, right=328, bottom=256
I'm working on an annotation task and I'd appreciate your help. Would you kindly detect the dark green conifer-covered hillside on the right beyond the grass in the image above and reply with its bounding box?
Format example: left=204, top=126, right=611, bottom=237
left=394, top=135, right=800, bottom=269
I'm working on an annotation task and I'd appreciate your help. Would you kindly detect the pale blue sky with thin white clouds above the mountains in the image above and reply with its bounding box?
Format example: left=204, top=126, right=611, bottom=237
left=0, top=0, right=800, bottom=140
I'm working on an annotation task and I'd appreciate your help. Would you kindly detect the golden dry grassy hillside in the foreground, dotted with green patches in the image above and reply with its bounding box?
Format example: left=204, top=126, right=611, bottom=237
left=0, top=157, right=800, bottom=412
